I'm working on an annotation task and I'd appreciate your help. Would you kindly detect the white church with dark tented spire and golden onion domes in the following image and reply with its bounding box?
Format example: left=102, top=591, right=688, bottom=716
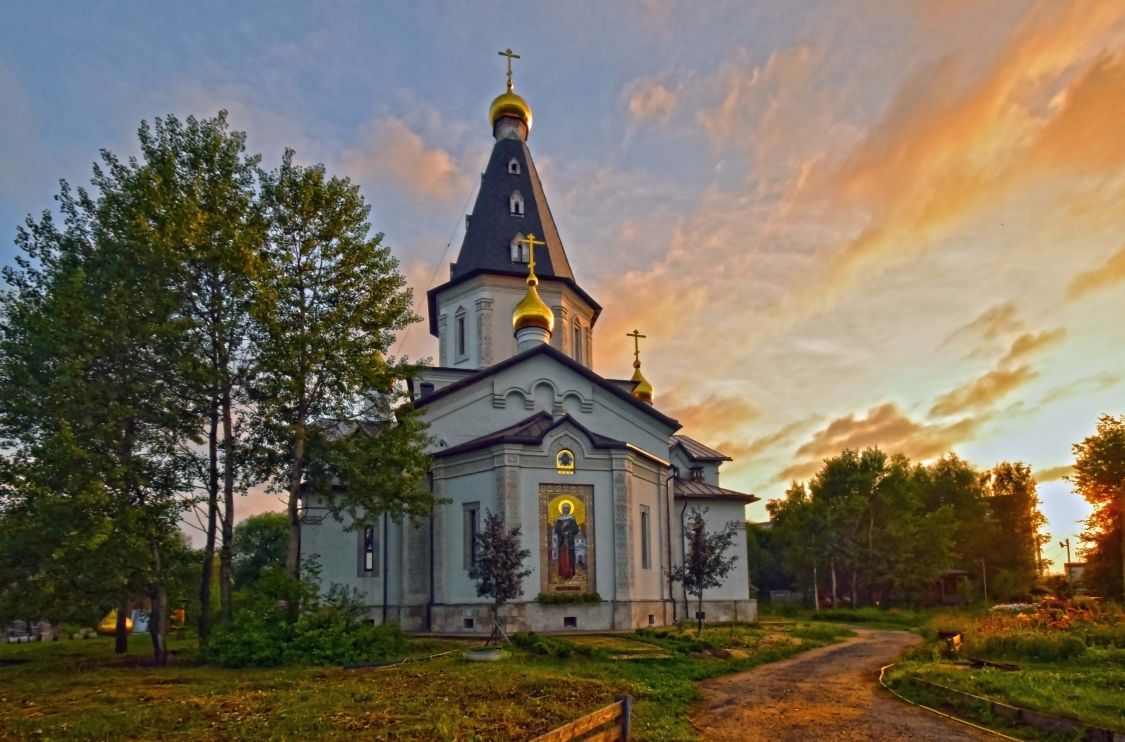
left=302, top=56, right=757, bottom=635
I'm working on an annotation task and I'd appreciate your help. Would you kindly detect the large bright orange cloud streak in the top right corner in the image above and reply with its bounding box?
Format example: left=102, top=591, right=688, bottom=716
left=791, top=1, right=1125, bottom=308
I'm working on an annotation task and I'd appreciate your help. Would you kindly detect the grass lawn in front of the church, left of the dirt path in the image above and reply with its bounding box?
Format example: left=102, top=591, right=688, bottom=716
left=0, top=623, right=849, bottom=740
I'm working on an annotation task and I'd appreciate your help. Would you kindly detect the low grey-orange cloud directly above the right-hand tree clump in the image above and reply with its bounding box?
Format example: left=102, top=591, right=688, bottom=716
left=774, top=402, right=983, bottom=482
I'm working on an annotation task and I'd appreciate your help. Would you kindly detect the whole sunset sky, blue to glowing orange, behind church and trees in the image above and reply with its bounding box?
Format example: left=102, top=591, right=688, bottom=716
left=0, top=0, right=1125, bottom=565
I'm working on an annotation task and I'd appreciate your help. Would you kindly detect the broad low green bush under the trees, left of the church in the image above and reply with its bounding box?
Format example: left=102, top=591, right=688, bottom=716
left=203, top=568, right=405, bottom=668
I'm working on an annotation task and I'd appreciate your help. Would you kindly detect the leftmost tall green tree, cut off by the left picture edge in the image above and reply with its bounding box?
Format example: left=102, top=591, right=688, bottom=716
left=0, top=143, right=199, bottom=662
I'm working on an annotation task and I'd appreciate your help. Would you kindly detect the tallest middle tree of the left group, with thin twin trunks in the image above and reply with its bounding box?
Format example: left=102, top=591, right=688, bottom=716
left=126, top=111, right=263, bottom=640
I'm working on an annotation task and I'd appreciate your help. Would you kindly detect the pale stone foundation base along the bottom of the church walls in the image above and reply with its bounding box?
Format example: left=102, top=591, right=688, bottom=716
left=368, top=600, right=758, bottom=635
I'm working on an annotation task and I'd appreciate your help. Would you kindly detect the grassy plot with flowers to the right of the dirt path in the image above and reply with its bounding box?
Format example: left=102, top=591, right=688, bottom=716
left=889, top=609, right=1125, bottom=736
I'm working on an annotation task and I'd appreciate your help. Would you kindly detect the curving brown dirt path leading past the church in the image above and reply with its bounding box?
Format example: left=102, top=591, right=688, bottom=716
left=692, top=628, right=996, bottom=741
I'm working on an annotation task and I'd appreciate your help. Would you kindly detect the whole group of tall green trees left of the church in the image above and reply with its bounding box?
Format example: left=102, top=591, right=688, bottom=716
left=0, top=112, right=432, bottom=661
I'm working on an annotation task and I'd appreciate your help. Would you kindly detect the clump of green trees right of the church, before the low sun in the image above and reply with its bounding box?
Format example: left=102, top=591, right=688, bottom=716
left=767, top=449, right=1045, bottom=605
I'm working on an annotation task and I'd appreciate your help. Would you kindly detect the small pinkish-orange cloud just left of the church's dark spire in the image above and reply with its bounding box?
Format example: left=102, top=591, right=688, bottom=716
left=341, top=117, right=469, bottom=200
